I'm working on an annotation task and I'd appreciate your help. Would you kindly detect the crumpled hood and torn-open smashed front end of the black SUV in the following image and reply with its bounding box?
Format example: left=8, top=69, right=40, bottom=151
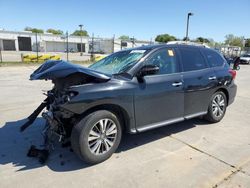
left=20, top=61, right=110, bottom=163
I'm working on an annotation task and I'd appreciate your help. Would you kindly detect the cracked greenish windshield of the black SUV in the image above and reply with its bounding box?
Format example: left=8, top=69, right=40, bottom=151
left=89, top=50, right=147, bottom=74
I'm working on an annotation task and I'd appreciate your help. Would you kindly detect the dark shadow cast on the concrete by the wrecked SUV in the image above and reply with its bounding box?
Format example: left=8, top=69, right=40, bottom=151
left=0, top=117, right=207, bottom=172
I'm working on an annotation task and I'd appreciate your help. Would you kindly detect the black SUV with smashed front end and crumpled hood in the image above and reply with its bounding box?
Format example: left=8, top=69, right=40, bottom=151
left=21, top=45, right=237, bottom=164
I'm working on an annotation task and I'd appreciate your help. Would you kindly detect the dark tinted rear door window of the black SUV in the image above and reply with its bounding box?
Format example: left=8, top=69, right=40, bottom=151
left=180, top=48, right=208, bottom=71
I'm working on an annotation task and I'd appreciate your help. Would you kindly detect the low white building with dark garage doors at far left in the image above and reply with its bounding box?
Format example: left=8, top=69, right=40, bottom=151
left=0, top=30, right=89, bottom=52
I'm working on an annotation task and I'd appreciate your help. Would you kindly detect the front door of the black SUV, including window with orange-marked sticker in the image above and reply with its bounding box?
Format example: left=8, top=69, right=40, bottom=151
left=134, top=48, right=184, bottom=131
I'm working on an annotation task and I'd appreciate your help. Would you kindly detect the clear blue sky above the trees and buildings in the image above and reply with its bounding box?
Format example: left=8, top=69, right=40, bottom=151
left=0, top=0, right=250, bottom=42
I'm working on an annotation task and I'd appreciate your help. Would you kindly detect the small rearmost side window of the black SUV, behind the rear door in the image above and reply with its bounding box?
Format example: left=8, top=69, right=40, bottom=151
left=204, top=49, right=225, bottom=67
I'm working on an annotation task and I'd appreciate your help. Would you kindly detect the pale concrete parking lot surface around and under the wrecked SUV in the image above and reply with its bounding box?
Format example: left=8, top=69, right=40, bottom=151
left=0, top=65, right=250, bottom=188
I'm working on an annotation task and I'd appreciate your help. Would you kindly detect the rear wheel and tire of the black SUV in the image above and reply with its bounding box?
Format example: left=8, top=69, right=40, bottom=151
left=204, top=91, right=227, bottom=123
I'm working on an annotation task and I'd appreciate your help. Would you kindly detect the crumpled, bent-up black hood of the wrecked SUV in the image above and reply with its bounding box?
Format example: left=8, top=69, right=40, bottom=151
left=30, top=60, right=110, bottom=80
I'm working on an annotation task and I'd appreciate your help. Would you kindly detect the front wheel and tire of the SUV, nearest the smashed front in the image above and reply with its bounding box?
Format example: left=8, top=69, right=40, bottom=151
left=71, top=110, right=122, bottom=164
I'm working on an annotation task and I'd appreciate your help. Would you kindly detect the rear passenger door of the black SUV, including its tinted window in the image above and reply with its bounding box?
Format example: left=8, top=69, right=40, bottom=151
left=179, top=47, right=217, bottom=118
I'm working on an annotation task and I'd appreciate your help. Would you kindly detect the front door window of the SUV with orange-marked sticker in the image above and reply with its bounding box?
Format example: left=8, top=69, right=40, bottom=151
left=146, top=48, right=179, bottom=74
